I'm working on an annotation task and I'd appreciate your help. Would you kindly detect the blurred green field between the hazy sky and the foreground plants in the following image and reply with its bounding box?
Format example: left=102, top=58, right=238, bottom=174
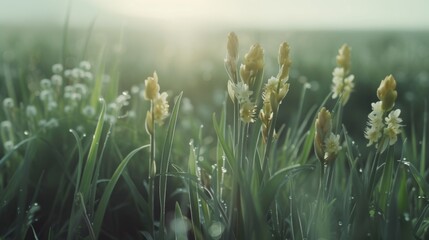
left=0, top=23, right=429, bottom=141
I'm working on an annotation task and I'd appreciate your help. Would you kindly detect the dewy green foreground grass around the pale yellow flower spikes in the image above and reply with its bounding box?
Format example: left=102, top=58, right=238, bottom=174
left=0, top=19, right=429, bottom=239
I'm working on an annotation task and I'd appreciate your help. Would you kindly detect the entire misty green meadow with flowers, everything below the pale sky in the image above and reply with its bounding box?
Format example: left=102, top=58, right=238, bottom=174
left=0, top=21, right=429, bottom=239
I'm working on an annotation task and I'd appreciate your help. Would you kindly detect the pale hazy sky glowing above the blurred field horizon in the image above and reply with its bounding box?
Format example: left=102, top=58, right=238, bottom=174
left=0, top=0, right=429, bottom=30
